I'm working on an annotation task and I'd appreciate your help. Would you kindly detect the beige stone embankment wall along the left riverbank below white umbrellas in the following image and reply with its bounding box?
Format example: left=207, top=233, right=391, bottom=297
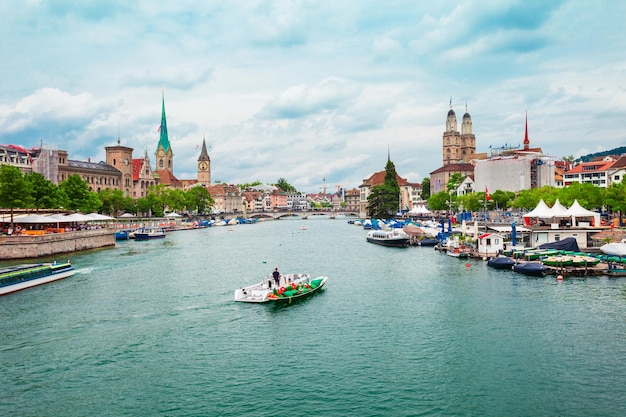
left=0, top=229, right=115, bottom=260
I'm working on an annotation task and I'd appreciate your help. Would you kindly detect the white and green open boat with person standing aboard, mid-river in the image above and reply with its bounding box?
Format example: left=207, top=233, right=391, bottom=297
left=235, top=274, right=328, bottom=303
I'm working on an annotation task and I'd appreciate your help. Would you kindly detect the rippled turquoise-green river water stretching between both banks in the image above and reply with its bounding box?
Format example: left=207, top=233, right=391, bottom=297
left=0, top=219, right=626, bottom=417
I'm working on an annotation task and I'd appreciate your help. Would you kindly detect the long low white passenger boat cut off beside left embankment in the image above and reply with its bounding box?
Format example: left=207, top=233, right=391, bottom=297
left=0, top=261, right=75, bottom=295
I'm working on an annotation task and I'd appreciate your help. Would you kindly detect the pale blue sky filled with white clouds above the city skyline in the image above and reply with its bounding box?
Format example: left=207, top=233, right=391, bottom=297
left=0, top=0, right=626, bottom=193
